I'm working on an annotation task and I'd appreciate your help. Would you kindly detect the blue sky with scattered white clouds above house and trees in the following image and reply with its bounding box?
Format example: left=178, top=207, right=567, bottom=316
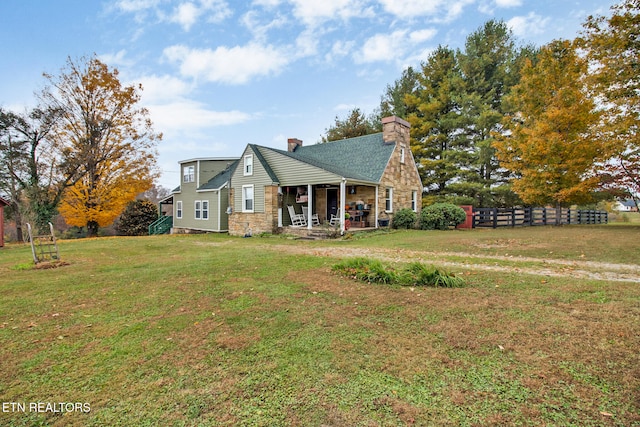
left=0, top=0, right=617, bottom=188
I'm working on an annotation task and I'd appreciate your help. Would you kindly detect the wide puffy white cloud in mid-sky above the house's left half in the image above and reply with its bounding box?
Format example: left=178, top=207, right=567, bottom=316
left=163, top=42, right=292, bottom=84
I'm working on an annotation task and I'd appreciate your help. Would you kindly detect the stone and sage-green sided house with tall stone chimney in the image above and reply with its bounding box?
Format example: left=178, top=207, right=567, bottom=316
left=172, top=116, right=422, bottom=236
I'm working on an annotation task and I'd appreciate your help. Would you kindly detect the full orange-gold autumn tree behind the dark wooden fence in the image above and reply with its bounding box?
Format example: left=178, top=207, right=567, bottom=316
left=493, top=40, right=604, bottom=206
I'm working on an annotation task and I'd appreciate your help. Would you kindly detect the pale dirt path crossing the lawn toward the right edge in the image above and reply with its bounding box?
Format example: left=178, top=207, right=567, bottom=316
left=266, top=245, right=640, bottom=283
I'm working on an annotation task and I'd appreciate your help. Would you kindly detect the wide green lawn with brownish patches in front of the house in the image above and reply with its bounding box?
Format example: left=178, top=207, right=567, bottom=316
left=0, top=224, right=640, bottom=426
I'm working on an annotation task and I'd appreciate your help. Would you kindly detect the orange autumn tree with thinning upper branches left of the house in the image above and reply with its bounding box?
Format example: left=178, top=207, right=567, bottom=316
left=41, top=56, right=162, bottom=236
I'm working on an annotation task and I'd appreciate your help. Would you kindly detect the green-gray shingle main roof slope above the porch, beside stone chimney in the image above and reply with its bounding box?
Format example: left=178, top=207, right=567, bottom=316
left=260, top=133, right=395, bottom=182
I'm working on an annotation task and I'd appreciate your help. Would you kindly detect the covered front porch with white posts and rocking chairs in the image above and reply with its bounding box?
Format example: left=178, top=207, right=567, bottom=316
left=278, top=179, right=381, bottom=233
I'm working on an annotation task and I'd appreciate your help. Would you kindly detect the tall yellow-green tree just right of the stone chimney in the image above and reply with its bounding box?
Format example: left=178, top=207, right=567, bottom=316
left=405, top=46, right=471, bottom=203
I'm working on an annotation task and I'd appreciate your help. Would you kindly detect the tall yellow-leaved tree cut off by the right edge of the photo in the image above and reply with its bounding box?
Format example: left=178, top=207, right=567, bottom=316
left=578, top=0, right=640, bottom=205
